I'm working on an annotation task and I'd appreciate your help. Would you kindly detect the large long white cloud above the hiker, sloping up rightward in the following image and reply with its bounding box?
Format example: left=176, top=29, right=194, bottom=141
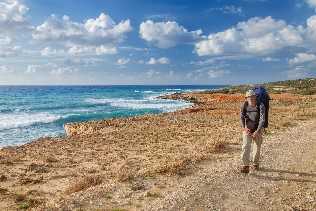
left=195, top=16, right=303, bottom=56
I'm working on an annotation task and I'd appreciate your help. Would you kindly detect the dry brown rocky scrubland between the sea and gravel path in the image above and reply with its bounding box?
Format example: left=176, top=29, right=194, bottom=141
left=0, top=87, right=316, bottom=210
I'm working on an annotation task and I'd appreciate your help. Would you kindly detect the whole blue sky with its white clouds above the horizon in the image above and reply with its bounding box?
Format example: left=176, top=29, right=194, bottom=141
left=0, top=0, right=316, bottom=85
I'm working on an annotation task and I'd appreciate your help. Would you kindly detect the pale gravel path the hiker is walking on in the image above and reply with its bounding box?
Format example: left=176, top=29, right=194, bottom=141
left=144, top=120, right=316, bottom=210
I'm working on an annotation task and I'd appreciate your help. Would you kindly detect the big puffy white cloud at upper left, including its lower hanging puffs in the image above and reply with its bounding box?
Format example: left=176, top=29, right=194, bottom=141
left=32, top=13, right=132, bottom=55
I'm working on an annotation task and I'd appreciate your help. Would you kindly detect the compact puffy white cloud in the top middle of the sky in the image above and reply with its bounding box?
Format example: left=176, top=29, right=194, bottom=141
left=139, top=20, right=202, bottom=48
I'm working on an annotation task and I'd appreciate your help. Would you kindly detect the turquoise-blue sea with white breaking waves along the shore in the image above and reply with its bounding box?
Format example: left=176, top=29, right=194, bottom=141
left=0, top=85, right=223, bottom=148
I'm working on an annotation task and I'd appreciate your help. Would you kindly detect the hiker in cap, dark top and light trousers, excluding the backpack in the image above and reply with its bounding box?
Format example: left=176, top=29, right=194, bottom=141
left=240, top=90, right=266, bottom=173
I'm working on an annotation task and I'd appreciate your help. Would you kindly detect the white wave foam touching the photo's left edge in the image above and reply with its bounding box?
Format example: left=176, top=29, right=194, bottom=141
left=0, top=112, right=62, bottom=130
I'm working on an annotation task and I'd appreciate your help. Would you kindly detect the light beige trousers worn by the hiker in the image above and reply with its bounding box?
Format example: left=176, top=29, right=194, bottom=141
left=241, top=131, right=262, bottom=166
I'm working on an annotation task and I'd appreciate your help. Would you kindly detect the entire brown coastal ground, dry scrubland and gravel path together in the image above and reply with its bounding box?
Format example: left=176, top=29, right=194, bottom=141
left=0, top=93, right=316, bottom=211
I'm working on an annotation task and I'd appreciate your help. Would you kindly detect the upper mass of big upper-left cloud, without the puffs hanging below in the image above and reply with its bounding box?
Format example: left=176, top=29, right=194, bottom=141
left=33, top=13, right=132, bottom=45
